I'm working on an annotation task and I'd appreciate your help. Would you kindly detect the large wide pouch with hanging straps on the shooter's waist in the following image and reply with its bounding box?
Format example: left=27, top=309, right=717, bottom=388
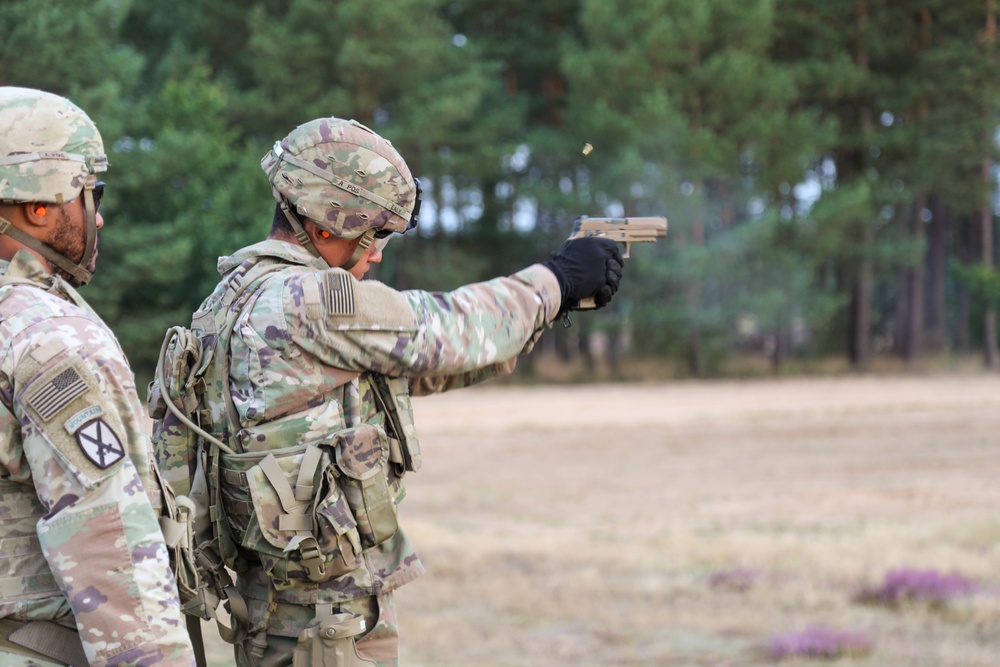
left=219, top=445, right=361, bottom=590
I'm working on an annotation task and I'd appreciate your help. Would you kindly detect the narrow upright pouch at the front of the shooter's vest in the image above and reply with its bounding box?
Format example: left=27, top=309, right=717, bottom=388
left=331, top=424, right=399, bottom=549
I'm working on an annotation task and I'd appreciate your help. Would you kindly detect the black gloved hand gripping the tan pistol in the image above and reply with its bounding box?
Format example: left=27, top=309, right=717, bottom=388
left=545, top=236, right=625, bottom=314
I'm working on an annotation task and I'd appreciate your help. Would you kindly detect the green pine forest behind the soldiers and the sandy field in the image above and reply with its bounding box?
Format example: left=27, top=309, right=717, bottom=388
left=0, top=0, right=1000, bottom=380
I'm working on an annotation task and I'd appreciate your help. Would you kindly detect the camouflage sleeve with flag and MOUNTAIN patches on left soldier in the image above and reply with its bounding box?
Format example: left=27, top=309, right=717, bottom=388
left=13, top=316, right=194, bottom=667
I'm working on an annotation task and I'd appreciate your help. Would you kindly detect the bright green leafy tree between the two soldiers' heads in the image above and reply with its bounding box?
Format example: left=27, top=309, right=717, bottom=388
left=87, top=67, right=273, bottom=378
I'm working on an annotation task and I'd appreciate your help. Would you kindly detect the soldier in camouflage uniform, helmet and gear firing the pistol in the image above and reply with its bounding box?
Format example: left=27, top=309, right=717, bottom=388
left=150, top=118, right=620, bottom=667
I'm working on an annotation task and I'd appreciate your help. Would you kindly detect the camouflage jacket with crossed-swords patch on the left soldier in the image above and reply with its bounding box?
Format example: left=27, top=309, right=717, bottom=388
left=0, top=250, right=194, bottom=667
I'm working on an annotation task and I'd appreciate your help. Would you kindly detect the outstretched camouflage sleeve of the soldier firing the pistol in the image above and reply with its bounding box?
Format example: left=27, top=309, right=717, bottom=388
left=274, top=265, right=560, bottom=380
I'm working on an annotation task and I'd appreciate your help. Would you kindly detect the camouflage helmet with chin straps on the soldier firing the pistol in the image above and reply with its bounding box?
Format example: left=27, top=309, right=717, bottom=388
left=261, top=118, right=420, bottom=269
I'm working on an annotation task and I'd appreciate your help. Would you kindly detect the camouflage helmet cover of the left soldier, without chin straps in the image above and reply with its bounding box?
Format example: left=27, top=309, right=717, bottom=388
left=0, top=86, right=108, bottom=204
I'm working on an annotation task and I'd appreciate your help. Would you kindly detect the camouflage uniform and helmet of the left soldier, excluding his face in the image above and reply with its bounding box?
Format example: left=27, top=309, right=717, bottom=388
left=0, top=87, right=194, bottom=667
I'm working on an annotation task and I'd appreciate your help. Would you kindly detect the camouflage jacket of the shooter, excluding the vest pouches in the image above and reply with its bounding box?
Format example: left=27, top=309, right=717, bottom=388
left=158, top=240, right=560, bottom=664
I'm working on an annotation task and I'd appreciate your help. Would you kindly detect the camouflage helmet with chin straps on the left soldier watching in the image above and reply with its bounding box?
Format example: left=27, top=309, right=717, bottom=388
left=0, top=86, right=108, bottom=285
